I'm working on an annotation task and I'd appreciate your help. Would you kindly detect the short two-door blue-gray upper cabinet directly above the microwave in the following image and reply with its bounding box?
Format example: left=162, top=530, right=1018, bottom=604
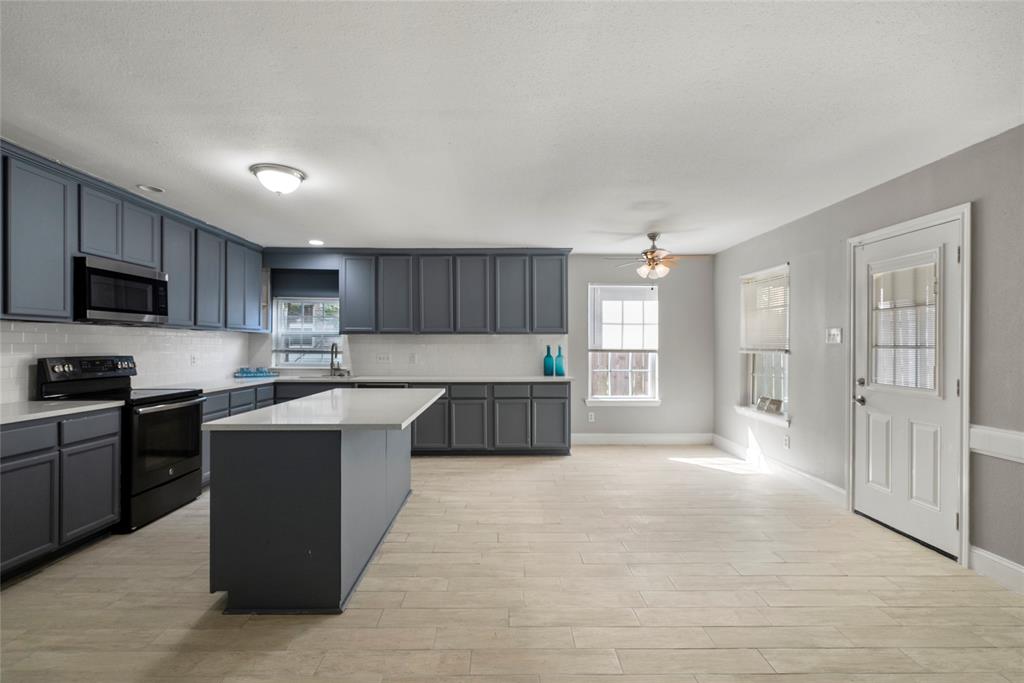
left=78, top=185, right=161, bottom=268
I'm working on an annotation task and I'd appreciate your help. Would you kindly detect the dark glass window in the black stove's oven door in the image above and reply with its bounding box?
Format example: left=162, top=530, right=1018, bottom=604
left=135, top=405, right=202, bottom=472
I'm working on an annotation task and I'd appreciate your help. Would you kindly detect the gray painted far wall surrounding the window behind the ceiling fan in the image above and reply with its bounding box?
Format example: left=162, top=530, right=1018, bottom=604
left=568, top=253, right=715, bottom=434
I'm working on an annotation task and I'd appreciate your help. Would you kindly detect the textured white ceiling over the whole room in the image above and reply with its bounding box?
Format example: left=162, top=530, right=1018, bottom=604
left=0, top=1, right=1024, bottom=253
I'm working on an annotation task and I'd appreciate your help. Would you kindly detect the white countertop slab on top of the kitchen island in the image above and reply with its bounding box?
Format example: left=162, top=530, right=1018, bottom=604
left=203, top=388, right=444, bottom=431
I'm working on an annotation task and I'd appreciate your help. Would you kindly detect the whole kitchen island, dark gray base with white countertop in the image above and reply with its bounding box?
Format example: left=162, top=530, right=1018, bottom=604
left=203, top=389, right=443, bottom=613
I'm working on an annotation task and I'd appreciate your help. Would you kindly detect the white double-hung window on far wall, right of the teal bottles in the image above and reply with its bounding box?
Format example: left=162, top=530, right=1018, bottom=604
left=588, top=285, right=658, bottom=404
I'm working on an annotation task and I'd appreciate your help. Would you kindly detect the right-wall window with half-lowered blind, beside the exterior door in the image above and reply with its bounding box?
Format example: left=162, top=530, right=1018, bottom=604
left=739, top=265, right=790, bottom=414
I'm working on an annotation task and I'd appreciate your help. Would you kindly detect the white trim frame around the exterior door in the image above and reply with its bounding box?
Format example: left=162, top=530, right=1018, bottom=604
left=845, top=202, right=971, bottom=566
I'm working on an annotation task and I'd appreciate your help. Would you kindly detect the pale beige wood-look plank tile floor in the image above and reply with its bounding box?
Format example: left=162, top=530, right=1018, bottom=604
left=0, top=446, right=1024, bottom=683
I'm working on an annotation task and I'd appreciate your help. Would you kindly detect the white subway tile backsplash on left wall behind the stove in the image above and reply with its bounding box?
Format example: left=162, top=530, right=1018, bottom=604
left=0, top=321, right=254, bottom=402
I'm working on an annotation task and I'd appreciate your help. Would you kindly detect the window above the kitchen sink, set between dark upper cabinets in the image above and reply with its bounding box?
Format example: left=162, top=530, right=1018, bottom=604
left=271, top=297, right=342, bottom=368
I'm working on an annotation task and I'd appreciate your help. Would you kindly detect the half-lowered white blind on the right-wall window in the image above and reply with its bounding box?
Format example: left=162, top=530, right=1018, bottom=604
left=739, top=265, right=790, bottom=353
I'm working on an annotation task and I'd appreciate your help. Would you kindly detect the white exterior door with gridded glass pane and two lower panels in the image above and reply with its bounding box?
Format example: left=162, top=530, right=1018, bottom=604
left=853, top=215, right=964, bottom=556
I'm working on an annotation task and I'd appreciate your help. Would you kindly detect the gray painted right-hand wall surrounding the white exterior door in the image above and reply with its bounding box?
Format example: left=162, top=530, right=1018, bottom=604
left=715, top=126, right=1024, bottom=563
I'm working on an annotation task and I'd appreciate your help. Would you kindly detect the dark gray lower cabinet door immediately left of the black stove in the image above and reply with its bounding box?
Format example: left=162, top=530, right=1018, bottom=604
left=60, top=436, right=121, bottom=543
